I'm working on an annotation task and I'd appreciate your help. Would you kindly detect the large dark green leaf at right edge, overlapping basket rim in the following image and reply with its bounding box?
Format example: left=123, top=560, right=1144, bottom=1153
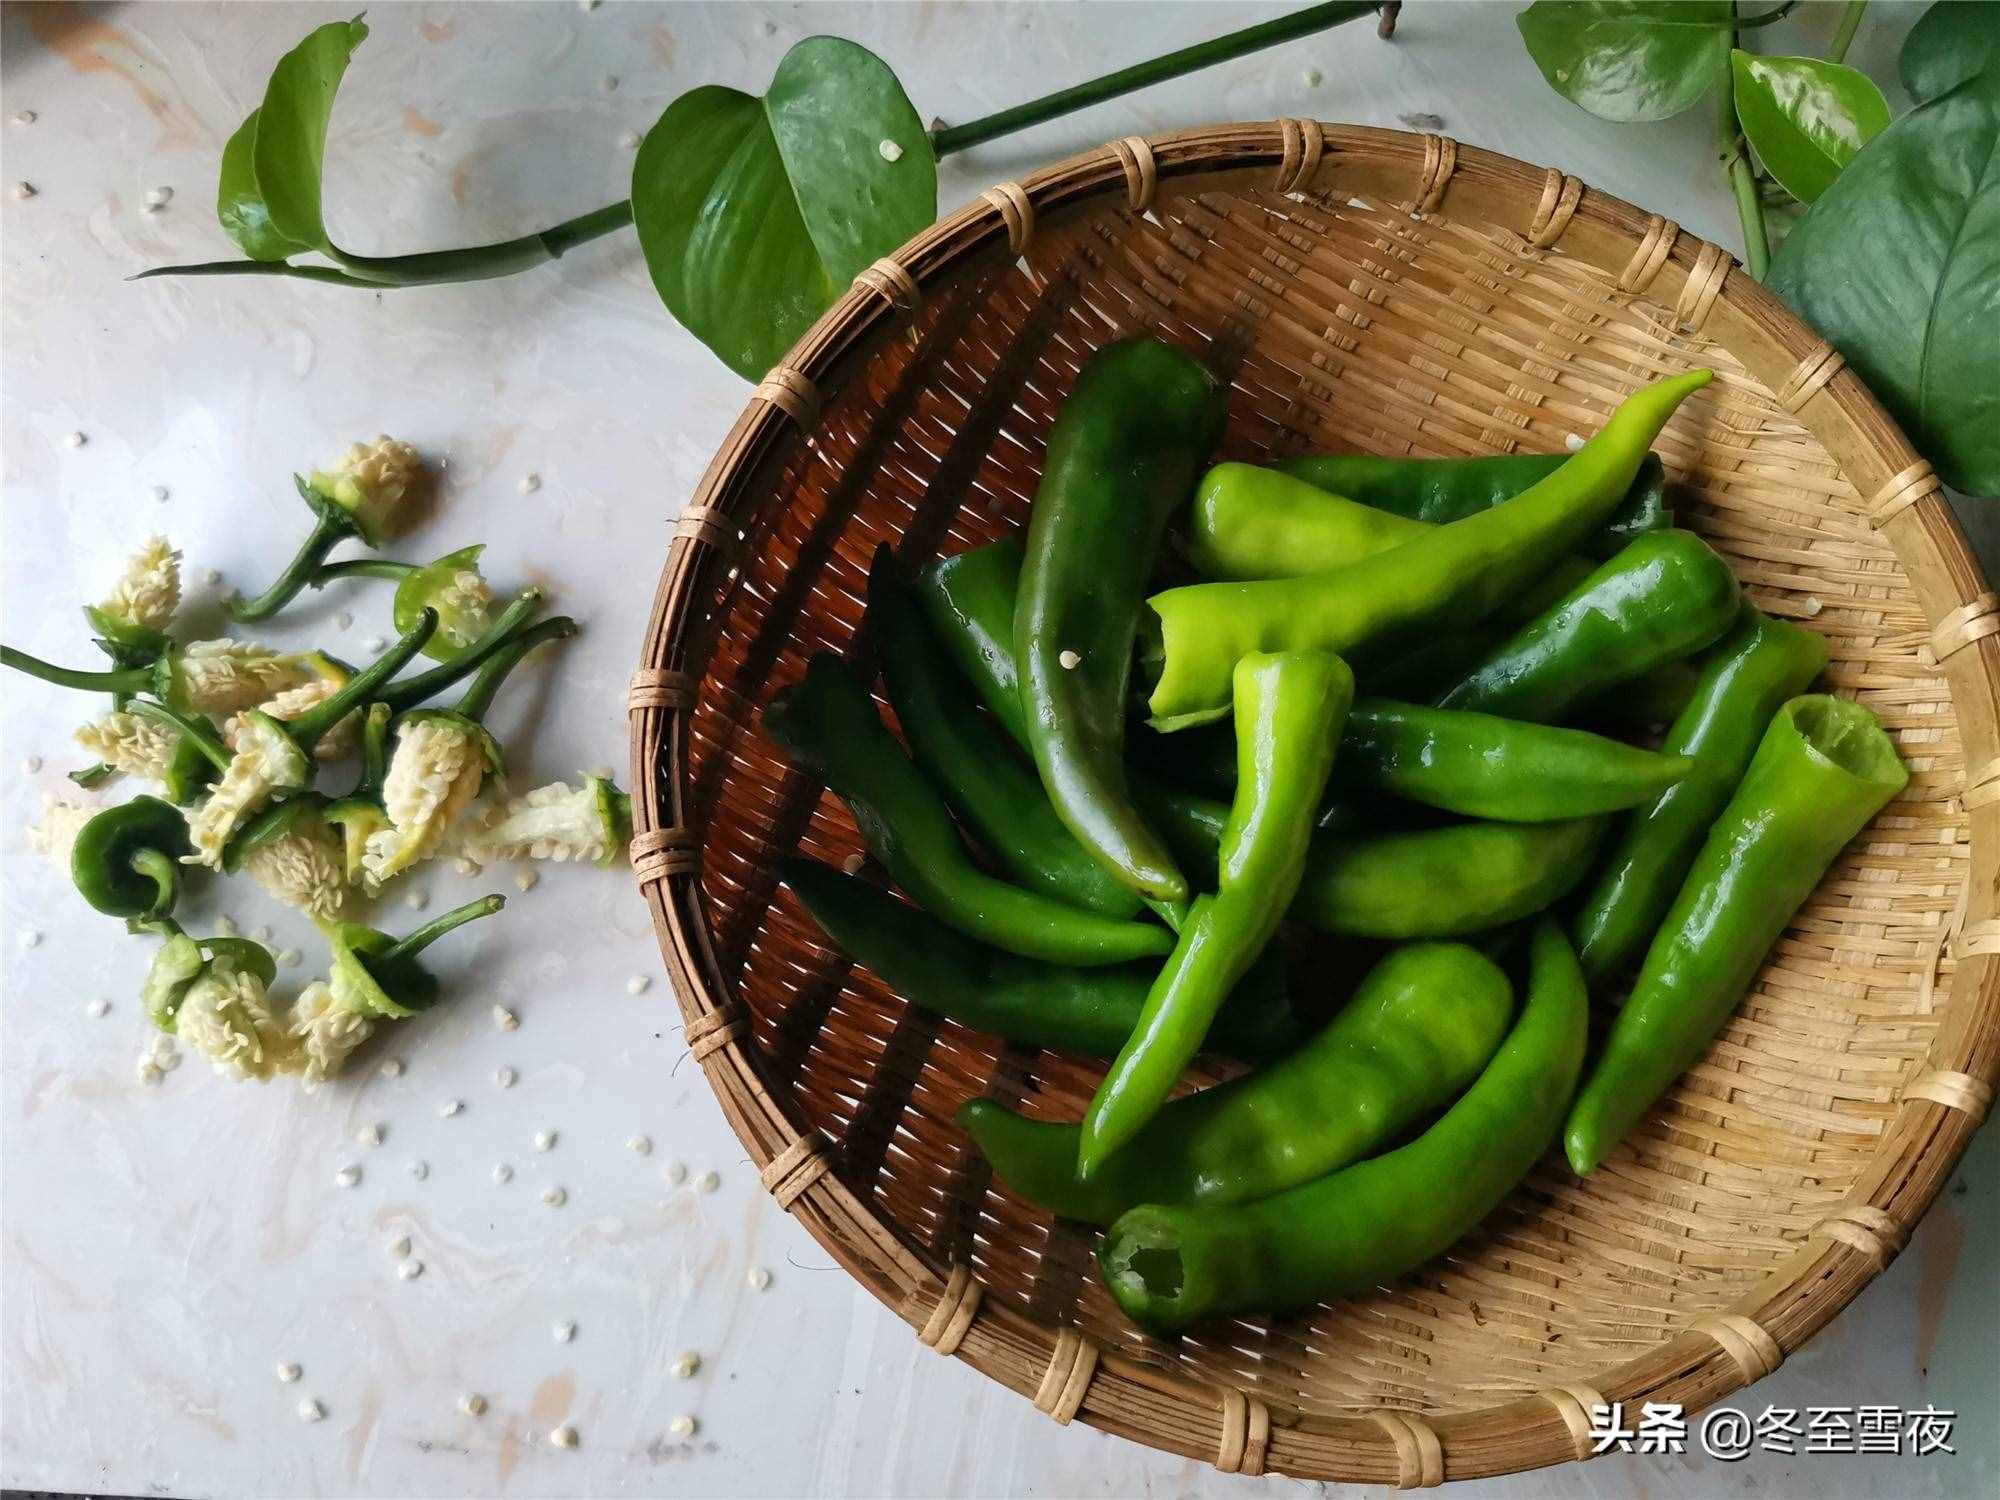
left=1770, top=68, right=2000, bottom=498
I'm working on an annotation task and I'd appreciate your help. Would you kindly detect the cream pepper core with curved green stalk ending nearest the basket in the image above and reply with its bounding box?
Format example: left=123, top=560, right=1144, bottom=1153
left=362, top=610, right=576, bottom=888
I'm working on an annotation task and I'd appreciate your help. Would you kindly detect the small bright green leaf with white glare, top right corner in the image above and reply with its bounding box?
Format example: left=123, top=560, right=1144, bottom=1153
left=1730, top=52, right=1888, bottom=204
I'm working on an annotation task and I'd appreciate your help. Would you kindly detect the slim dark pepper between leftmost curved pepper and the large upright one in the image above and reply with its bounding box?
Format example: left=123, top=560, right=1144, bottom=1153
left=868, top=544, right=1140, bottom=916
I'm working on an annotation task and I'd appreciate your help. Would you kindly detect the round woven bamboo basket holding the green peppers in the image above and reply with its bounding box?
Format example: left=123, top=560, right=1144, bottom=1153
left=630, top=120, right=2000, bottom=1486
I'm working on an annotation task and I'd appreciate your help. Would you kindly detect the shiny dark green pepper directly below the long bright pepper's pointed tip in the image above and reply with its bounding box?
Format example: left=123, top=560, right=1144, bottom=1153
left=1438, top=530, right=1742, bottom=724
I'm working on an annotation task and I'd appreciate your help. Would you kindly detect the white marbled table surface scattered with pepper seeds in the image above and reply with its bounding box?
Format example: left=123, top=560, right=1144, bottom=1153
left=0, top=0, right=2000, bottom=1496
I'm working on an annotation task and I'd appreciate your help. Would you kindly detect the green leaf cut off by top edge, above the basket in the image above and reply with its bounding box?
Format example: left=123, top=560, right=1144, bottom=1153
left=1514, top=0, right=1730, bottom=120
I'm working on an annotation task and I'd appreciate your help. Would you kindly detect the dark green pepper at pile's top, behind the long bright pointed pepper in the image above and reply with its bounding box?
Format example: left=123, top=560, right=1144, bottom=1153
left=1276, top=454, right=1672, bottom=558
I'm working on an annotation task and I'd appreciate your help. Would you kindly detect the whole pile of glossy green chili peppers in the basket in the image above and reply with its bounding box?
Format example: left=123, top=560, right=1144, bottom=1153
left=760, top=338, right=1908, bottom=1334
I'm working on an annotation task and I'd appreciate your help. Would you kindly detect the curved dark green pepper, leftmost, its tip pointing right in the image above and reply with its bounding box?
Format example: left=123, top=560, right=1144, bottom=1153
left=764, top=652, right=1174, bottom=964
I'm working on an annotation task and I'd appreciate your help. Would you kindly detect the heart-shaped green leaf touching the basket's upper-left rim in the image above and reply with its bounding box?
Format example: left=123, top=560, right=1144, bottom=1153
left=632, top=36, right=938, bottom=380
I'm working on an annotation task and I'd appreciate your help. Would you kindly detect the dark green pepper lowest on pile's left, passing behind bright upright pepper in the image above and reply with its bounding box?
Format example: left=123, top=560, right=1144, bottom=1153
left=780, top=858, right=1302, bottom=1064
